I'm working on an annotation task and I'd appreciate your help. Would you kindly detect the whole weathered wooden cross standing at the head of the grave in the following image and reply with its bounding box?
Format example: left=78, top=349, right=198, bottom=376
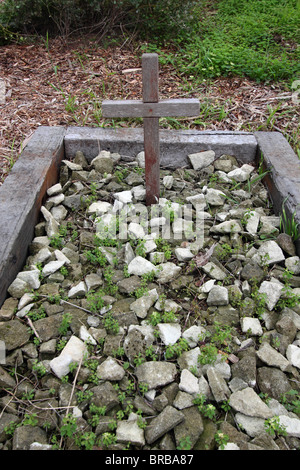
left=102, top=54, right=200, bottom=205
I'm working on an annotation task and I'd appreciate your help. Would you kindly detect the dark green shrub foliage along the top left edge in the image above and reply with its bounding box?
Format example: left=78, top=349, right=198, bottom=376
left=0, top=0, right=197, bottom=41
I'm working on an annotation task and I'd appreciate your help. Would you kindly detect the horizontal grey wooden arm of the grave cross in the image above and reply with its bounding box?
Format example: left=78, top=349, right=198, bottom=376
left=102, top=98, right=200, bottom=118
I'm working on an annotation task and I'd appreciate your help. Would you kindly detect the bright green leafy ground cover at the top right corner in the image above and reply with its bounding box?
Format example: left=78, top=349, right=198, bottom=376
left=155, top=0, right=300, bottom=82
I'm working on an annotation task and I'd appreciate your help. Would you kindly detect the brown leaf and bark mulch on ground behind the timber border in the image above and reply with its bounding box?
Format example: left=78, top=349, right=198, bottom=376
left=0, top=38, right=300, bottom=185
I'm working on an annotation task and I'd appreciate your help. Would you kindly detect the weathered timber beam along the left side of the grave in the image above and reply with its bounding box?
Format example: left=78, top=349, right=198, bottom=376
left=0, top=126, right=66, bottom=306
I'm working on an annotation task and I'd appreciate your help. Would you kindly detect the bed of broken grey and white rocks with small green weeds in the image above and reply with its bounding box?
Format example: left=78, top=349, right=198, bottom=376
left=0, top=151, right=300, bottom=450
